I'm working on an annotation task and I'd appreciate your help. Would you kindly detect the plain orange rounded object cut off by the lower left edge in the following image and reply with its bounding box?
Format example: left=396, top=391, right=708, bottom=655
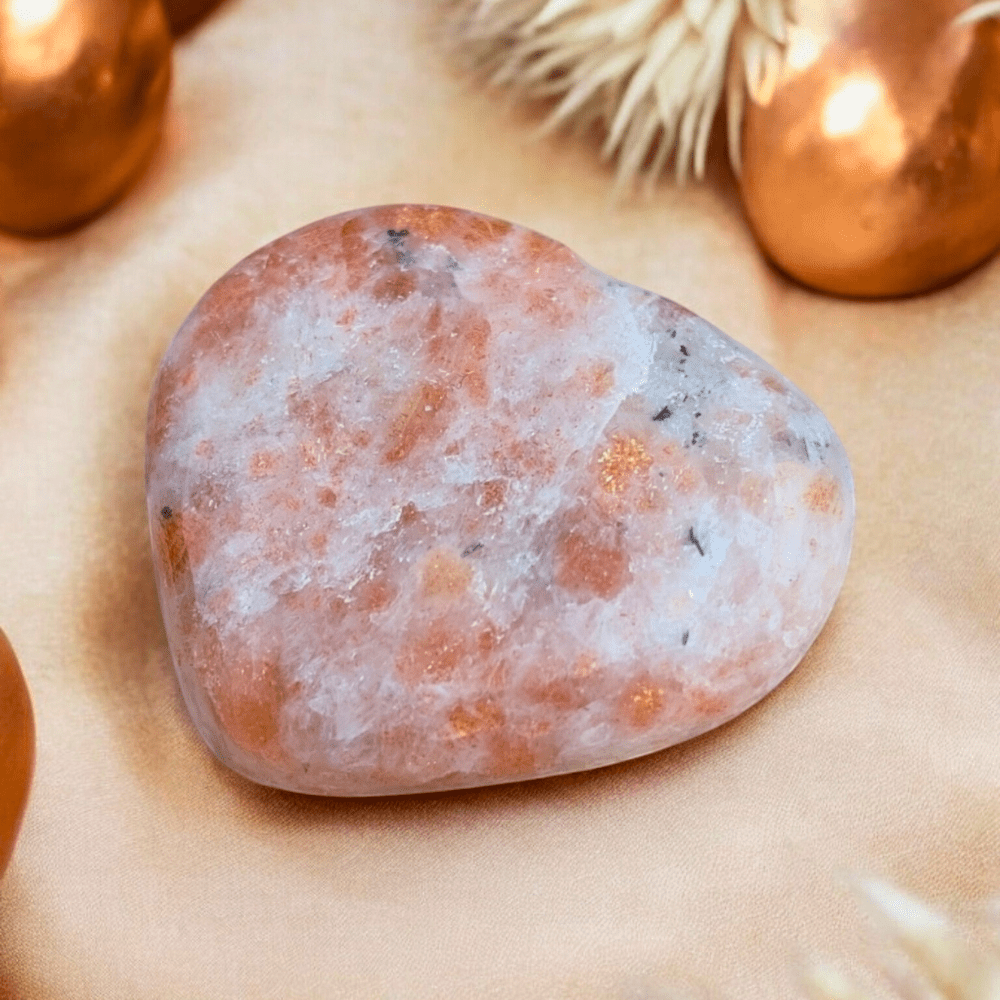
left=0, top=632, right=35, bottom=875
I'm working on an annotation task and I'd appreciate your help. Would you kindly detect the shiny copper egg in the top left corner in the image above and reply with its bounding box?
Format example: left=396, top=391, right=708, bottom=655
left=0, top=0, right=171, bottom=236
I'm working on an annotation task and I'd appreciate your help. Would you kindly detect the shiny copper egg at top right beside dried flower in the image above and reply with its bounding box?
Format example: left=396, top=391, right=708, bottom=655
left=740, top=0, right=1000, bottom=297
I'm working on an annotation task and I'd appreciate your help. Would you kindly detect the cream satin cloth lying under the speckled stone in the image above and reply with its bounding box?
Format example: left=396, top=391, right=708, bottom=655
left=0, top=0, right=1000, bottom=1000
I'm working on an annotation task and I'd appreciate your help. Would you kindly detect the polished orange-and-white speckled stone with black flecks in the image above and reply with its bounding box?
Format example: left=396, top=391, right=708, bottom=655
left=147, top=205, right=854, bottom=795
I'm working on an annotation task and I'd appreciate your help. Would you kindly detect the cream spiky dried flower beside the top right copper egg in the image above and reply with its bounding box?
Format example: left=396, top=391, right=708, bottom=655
left=441, top=0, right=791, bottom=189
